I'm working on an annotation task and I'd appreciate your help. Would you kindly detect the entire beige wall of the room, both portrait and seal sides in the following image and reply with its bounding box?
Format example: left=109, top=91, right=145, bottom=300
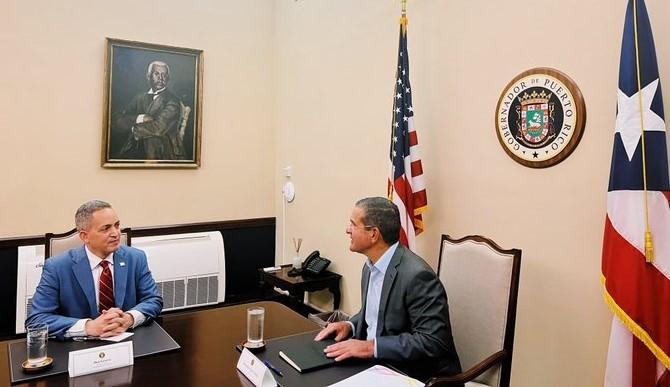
left=5, top=0, right=670, bottom=387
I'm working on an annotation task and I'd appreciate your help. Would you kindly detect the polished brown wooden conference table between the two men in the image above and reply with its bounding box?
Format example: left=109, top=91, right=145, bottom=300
left=0, top=302, right=328, bottom=387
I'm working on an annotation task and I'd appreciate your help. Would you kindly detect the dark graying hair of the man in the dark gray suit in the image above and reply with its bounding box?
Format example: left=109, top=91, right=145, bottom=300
left=356, top=197, right=400, bottom=245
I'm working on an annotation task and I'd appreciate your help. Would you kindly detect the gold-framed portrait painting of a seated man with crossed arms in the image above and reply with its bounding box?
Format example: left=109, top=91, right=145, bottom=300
left=102, top=38, right=202, bottom=168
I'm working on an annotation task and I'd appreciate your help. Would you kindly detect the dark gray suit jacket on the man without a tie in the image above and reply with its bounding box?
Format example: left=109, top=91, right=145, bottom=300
left=350, top=246, right=461, bottom=379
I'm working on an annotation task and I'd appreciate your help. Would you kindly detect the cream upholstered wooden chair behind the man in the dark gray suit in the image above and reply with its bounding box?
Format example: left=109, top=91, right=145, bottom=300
left=426, top=235, right=521, bottom=387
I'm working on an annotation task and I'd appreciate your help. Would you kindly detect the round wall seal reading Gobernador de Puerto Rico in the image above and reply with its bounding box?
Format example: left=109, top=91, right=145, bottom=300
left=496, top=67, right=586, bottom=168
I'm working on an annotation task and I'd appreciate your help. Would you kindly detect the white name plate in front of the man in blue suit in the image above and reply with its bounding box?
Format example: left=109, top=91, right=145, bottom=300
left=67, top=341, right=134, bottom=377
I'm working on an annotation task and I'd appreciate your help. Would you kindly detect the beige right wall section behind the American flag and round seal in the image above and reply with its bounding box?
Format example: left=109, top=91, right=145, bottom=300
left=276, top=0, right=670, bottom=387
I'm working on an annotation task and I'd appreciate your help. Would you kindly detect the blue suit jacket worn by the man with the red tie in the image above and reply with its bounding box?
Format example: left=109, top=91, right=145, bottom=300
left=26, top=246, right=163, bottom=340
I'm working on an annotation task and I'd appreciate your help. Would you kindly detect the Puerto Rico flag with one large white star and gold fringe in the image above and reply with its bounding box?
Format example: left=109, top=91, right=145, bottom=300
left=602, top=0, right=670, bottom=387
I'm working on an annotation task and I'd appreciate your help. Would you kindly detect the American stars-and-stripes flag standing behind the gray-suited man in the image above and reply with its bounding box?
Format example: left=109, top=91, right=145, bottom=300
left=388, top=15, right=428, bottom=250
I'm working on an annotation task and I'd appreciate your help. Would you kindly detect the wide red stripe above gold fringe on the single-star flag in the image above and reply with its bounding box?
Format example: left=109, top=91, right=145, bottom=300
left=602, top=216, right=670, bottom=353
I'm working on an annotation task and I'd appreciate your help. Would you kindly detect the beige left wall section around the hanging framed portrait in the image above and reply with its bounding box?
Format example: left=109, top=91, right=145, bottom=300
left=0, top=0, right=275, bottom=237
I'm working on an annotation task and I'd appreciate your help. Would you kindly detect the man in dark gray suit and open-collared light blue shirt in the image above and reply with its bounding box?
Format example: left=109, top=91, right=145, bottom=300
left=315, top=197, right=461, bottom=380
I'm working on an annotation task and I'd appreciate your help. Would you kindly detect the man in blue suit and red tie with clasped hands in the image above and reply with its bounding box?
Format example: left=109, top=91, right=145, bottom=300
left=26, top=200, right=163, bottom=340
